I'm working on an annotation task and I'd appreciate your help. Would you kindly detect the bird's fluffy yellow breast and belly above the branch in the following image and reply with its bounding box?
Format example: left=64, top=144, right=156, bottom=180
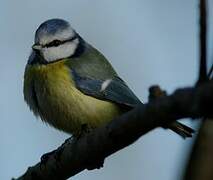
left=24, top=61, right=121, bottom=135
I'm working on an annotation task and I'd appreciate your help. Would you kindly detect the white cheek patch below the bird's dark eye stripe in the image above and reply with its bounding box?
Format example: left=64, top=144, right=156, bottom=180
left=41, top=39, right=79, bottom=62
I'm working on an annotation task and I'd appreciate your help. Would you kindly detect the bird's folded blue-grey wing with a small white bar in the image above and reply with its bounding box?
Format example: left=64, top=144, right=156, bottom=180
left=72, top=71, right=141, bottom=107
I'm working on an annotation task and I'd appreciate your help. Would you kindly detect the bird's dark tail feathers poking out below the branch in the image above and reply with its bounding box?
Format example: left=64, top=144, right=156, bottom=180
left=169, top=121, right=195, bottom=139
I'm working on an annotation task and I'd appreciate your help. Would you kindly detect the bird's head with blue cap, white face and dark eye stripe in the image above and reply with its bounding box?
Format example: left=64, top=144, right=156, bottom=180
left=32, top=19, right=84, bottom=63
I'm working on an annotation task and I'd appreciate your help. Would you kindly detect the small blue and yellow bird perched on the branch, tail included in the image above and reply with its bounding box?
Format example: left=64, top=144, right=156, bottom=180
left=23, top=19, right=194, bottom=138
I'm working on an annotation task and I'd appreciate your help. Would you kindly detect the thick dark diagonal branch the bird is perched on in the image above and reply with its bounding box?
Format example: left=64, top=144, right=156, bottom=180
left=15, top=81, right=213, bottom=180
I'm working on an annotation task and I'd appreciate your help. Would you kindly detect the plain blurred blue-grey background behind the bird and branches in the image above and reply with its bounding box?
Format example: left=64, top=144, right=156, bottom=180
left=0, top=0, right=213, bottom=180
